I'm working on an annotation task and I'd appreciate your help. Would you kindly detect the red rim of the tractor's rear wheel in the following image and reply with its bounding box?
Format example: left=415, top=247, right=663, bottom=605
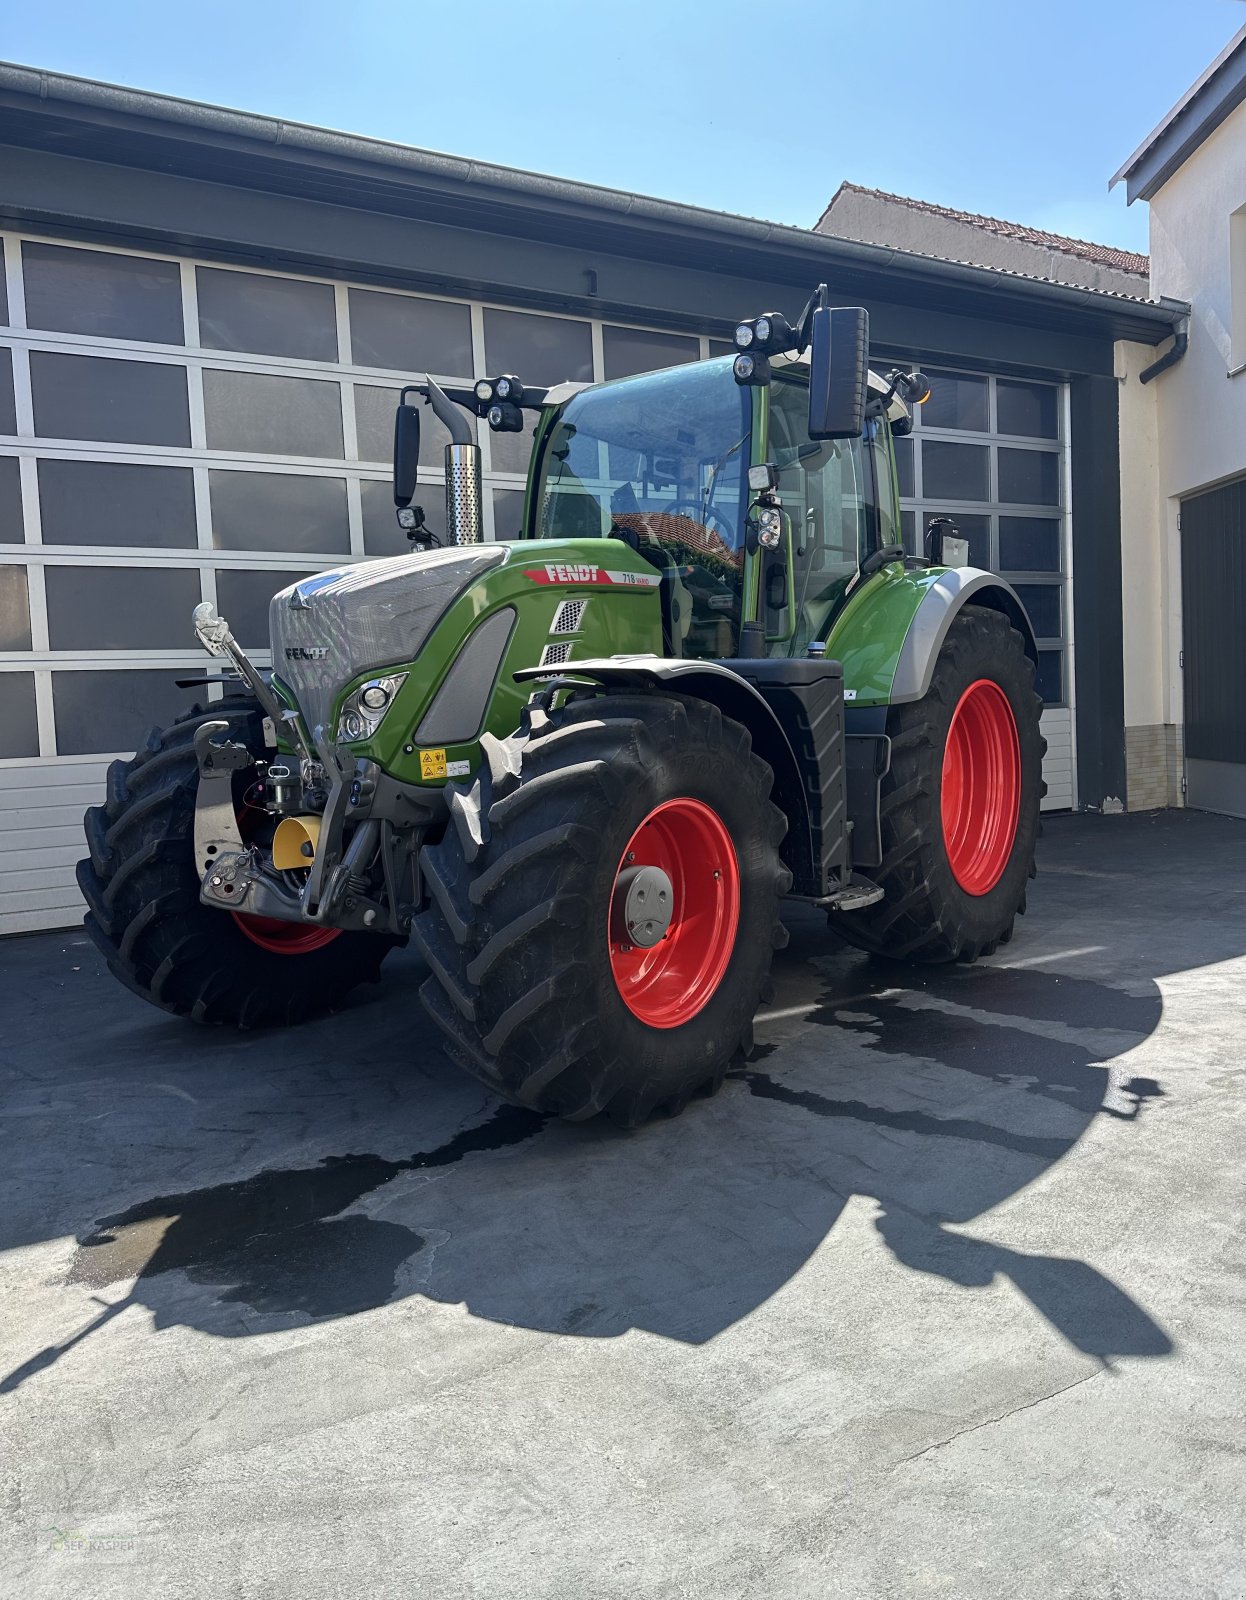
left=942, top=678, right=1020, bottom=894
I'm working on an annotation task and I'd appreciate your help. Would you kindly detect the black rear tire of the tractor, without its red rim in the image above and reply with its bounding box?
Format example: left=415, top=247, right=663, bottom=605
left=830, top=605, right=1046, bottom=963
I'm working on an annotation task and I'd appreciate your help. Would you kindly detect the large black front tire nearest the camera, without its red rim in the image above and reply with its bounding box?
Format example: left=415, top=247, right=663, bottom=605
left=413, top=694, right=792, bottom=1126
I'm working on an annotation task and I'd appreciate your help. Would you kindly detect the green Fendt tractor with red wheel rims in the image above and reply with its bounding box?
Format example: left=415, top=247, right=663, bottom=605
left=78, top=286, right=1043, bottom=1126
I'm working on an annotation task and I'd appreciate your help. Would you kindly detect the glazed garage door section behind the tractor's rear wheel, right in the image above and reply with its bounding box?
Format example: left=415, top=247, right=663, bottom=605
left=896, top=368, right=1076, bottom=810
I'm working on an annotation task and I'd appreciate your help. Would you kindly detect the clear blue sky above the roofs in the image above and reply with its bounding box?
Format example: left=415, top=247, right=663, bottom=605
left=0, top=0, right=1246, bottom=250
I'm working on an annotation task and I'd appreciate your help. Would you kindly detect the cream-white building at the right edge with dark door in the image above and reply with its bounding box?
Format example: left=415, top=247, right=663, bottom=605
left=1113, top=29, right=1246, bottom=816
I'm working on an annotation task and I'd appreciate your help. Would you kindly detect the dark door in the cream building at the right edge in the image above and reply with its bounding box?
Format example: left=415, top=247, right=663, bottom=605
left=1180, top=478, right=1246, bottom=816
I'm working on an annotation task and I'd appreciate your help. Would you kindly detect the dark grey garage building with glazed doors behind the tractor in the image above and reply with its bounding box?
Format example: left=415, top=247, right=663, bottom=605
left=0, top=67, right=1180, bottom=931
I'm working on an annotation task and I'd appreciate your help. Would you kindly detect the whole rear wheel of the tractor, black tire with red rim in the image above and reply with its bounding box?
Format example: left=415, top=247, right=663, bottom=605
left=830, top=605, right=1046, bottom=963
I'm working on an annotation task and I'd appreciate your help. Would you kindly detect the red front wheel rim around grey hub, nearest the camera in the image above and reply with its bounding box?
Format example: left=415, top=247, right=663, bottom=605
left=606, top=800, right=741, bottom=1027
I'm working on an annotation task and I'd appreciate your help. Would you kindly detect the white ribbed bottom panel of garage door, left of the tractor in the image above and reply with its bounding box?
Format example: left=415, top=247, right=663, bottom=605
left=0, top=760, right=109, bottom=934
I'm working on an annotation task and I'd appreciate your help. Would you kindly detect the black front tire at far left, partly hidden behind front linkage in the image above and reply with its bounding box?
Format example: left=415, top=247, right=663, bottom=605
left=78, top=698, right=395, bottom=1027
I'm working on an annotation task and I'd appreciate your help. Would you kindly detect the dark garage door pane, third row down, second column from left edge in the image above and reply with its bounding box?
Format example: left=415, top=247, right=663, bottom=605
left=38, top=461, right=195, bottom=549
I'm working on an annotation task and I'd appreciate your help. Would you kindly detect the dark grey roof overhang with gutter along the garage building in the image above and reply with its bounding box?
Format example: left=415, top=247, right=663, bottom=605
left=0, top=62, right=1188, bottom=344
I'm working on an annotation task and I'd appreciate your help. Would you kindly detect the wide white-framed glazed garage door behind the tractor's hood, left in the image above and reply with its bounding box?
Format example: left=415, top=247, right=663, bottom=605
left=0, top=234, right=710, bottom=933
